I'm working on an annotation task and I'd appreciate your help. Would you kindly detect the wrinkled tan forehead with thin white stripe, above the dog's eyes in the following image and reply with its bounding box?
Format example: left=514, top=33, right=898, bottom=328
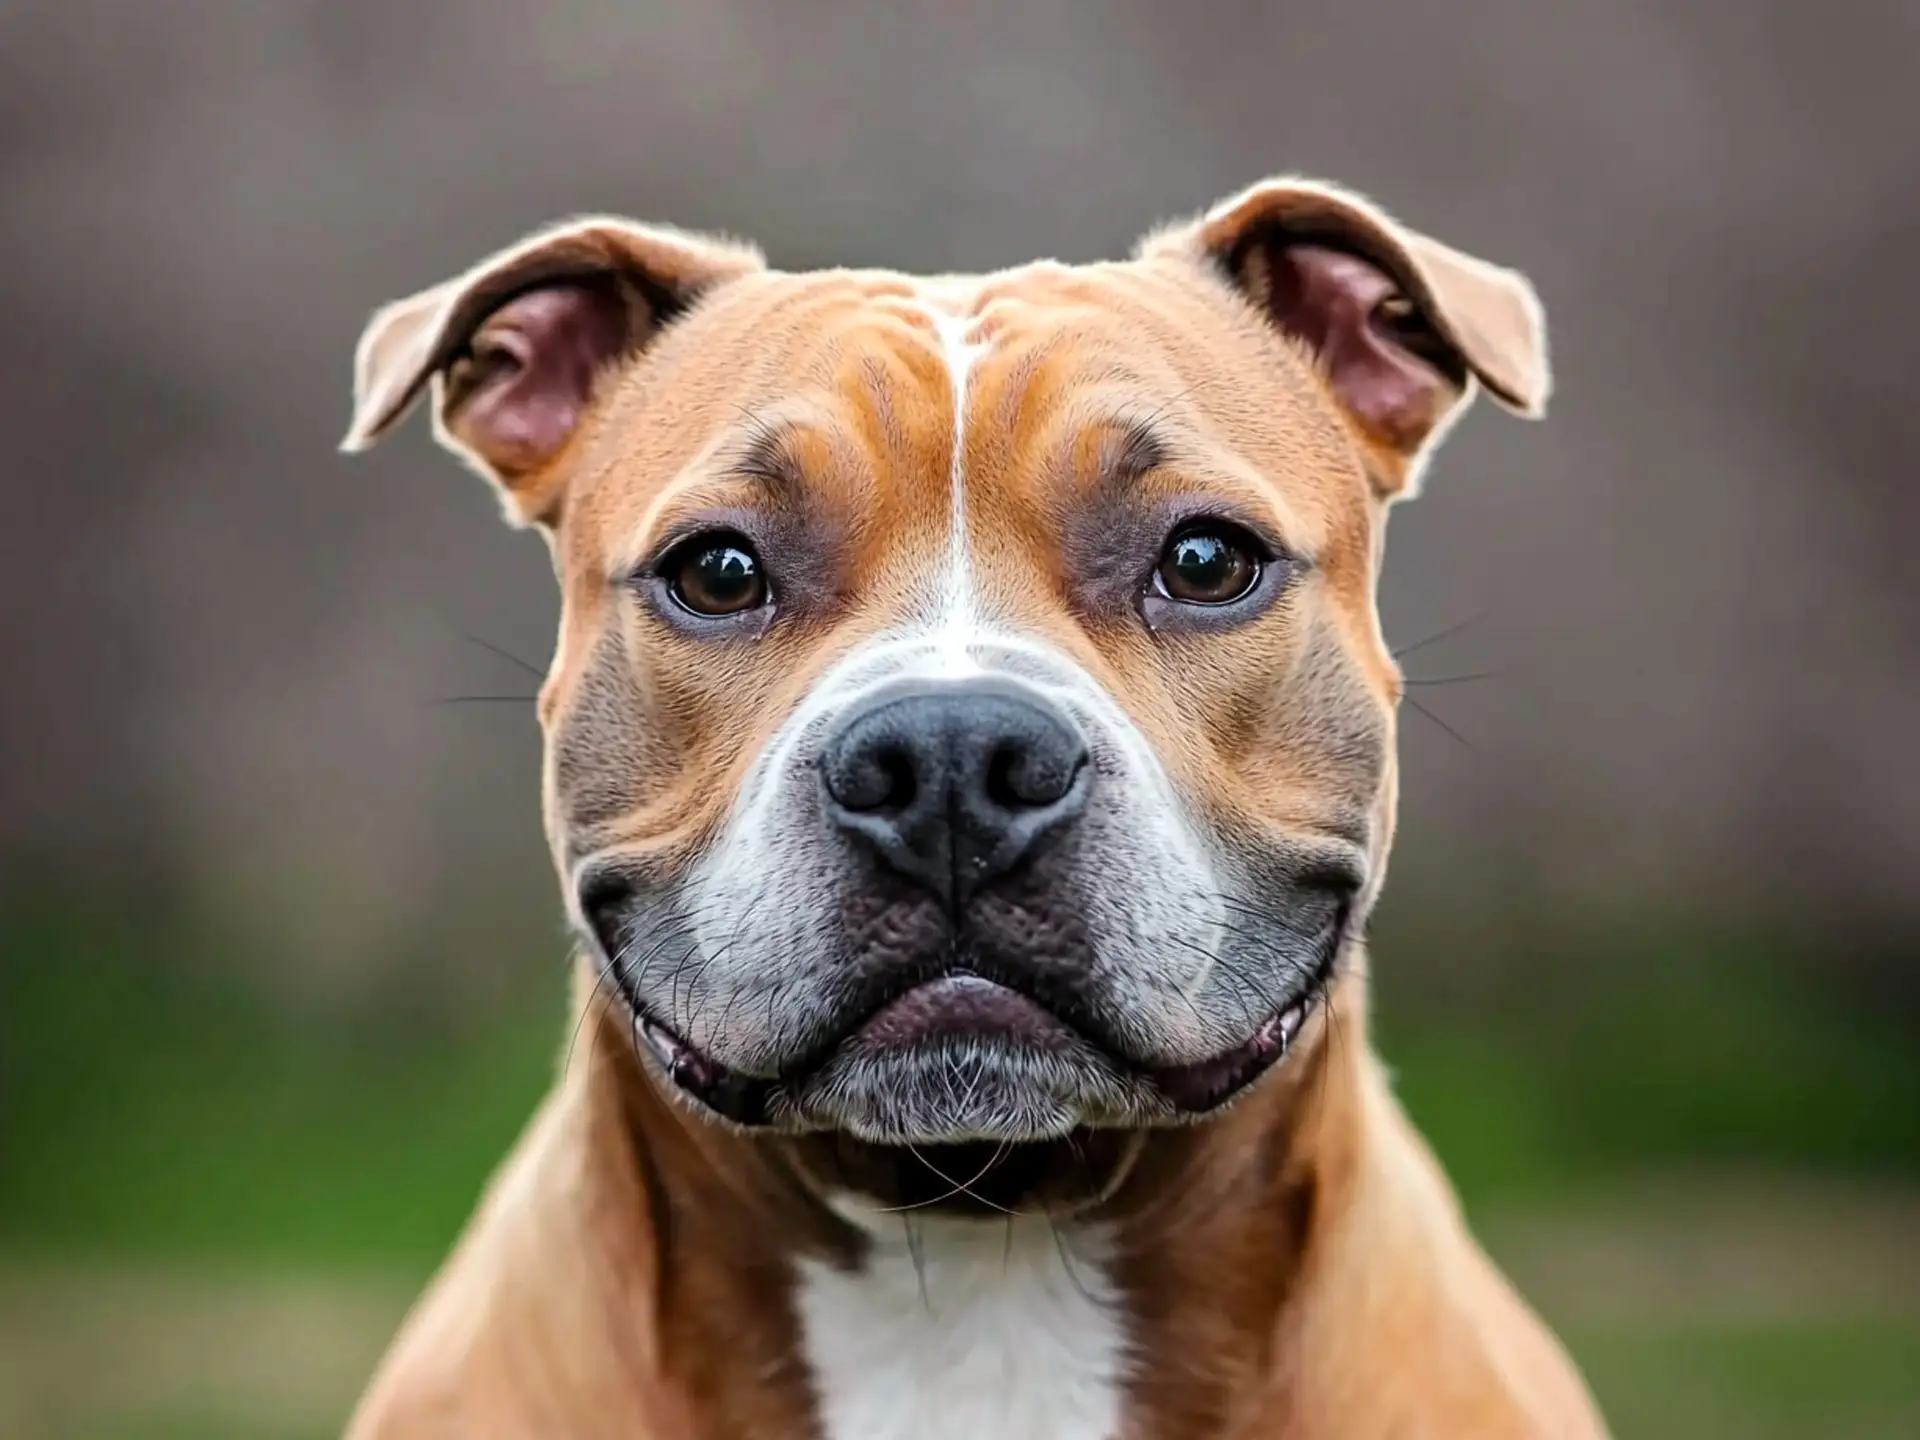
left=564, top=261, right=1367, bottom=570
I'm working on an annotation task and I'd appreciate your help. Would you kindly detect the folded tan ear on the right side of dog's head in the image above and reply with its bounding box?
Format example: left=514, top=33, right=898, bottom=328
left=1139, top=179, right=1551, bottom=499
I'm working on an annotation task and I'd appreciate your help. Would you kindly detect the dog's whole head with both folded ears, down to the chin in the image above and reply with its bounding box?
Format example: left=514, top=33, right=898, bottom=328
left=349, top=182, right=1548, bottom=1182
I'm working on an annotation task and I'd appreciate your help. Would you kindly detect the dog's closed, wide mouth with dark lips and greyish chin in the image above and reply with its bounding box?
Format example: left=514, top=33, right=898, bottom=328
left=634, top=925, right=1344, bottom=1144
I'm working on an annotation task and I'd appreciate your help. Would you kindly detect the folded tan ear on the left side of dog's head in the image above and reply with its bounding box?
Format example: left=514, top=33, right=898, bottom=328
left=342, top=219, right=764, bottom=526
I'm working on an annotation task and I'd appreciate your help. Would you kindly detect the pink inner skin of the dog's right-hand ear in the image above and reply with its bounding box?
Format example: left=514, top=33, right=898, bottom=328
left=1267, top=246, right=1455, bottom=451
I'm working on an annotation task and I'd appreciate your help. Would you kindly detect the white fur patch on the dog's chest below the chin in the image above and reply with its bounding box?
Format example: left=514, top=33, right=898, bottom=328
left=797, top=1219, right=1125, bottom=1440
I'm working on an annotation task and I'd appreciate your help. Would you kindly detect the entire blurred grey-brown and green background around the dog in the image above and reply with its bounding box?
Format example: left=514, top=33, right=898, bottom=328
left=0, top=0, right=1920, bottom=1436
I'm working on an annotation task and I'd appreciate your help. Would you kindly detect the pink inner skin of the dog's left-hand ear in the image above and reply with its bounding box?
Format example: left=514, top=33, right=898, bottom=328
left=447, top=282, right=630, bottom=474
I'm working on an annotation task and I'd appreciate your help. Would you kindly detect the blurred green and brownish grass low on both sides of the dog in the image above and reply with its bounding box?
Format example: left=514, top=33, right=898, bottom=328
left=0, top=902, right=1920, bottom=1436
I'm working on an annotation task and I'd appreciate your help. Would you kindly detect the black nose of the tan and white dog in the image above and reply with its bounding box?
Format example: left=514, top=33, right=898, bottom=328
left=820, top=680, right=1089, bottom=908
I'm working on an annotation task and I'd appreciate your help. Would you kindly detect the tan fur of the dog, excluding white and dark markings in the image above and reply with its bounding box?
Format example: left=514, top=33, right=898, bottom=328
left=349, top=182, right=1603, bottom=1440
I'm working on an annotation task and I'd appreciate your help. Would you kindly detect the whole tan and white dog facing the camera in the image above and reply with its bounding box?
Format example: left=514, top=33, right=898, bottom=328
left=334, top=180, right=1603, bottom=1440
